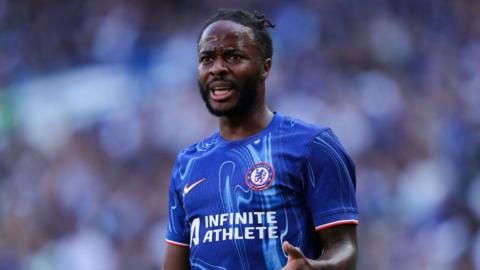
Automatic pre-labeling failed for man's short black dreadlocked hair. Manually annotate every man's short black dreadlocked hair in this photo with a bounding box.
[198,9,275,59]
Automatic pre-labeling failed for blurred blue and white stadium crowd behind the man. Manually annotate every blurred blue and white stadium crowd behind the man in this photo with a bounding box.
[0,0,480,270]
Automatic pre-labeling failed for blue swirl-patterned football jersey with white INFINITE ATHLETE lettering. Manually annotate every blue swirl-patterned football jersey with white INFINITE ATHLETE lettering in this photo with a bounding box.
[166,113,358,270]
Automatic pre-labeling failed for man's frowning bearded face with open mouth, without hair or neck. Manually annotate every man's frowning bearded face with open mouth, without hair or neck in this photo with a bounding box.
[198,20,263,116]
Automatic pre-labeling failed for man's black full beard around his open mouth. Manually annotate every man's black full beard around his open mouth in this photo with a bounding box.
[198,75,261,117]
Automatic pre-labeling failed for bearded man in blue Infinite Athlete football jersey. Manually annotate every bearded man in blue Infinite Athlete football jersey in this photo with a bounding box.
[164,10,358,270]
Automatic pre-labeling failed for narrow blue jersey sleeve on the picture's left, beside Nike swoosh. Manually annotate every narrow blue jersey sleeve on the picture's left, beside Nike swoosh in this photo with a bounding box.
[165,157,190,247]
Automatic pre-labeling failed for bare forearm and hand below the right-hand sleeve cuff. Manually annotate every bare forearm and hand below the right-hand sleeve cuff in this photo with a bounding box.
[283,224,357,270]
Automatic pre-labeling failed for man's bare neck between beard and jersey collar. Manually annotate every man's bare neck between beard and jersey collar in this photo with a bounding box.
[219,104,273,140]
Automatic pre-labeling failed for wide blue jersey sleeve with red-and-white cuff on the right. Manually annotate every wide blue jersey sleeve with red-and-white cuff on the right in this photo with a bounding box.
[304,129,358,231]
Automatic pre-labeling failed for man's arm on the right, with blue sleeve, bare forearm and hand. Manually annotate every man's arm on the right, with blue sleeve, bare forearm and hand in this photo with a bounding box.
[283,130,358,270]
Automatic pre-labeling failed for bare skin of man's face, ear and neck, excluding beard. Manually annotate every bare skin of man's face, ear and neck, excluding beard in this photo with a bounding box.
[198,21,273,140]
